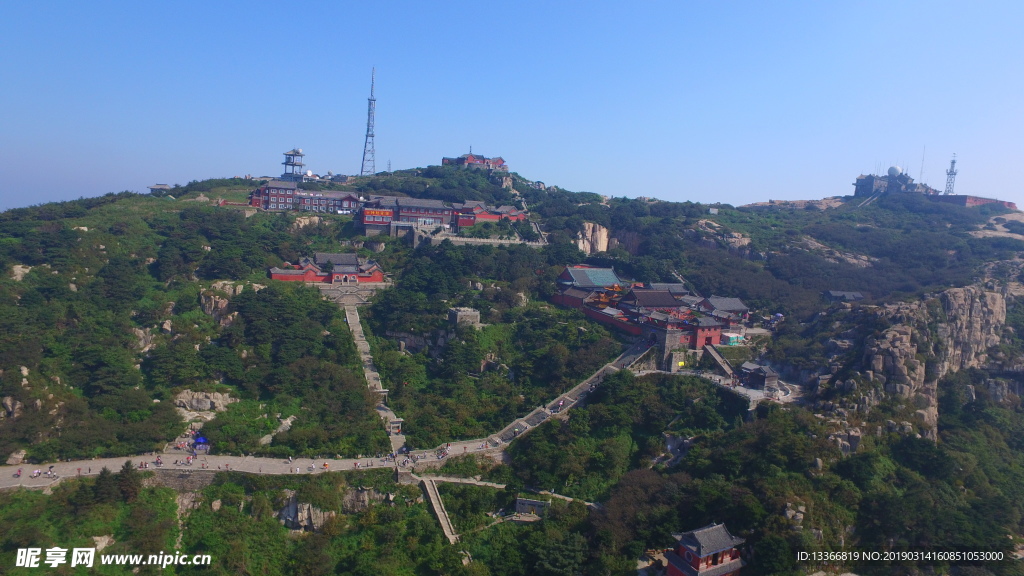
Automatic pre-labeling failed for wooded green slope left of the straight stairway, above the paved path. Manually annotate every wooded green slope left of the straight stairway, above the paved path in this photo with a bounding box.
[0,194,386,459]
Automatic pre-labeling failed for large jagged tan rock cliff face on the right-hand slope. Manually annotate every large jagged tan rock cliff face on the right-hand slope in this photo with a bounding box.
[862,286,1007,439]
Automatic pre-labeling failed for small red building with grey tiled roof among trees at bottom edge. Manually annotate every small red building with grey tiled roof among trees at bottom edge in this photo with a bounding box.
[665,524,745,576]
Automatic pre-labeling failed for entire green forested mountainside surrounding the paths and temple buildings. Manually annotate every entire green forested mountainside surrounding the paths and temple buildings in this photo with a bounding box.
[6,176,1024,575]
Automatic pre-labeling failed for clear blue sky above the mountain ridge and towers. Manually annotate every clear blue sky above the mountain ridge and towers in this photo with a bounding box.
[0,1,1024,208]
